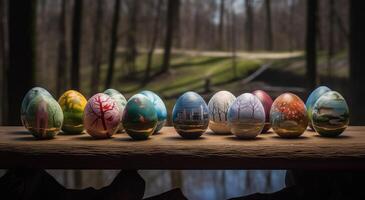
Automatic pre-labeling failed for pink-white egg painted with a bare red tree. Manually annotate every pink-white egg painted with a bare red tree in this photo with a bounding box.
[83,93,121,138]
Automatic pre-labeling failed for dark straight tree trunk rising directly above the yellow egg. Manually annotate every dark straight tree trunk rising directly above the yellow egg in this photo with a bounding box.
[71,0,83,90]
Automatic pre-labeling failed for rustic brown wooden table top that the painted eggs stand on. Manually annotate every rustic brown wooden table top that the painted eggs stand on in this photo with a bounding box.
[0,126,365,169]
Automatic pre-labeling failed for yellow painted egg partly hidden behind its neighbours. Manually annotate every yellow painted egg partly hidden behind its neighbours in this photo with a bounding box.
[58,90,87,134]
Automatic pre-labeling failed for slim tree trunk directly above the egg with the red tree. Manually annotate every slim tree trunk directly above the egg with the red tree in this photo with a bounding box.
[90,0,104,94]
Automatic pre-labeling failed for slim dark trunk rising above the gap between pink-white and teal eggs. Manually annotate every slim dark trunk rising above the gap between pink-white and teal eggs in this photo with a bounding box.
[105,0,120,89]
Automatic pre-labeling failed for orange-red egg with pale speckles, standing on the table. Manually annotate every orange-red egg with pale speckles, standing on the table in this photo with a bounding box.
[270,93,308,138]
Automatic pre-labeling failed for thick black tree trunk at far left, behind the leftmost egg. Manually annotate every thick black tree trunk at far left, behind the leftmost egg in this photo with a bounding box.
[7,0,36,125]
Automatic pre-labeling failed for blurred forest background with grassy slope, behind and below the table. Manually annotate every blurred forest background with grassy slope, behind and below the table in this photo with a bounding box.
[0,0,365,199]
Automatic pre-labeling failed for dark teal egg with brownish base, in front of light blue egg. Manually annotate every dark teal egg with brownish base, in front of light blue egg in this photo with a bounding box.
[123,94,158,140]
